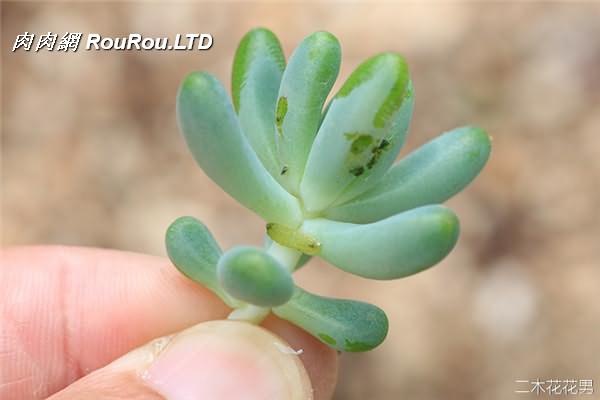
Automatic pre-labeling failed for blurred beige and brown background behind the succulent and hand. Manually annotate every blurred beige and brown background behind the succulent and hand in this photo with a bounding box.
[1,2,600,400]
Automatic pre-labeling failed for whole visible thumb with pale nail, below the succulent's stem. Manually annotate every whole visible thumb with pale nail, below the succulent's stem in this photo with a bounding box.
[50,321,313,400]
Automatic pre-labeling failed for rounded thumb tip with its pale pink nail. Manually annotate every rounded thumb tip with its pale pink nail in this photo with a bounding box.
[142,321,313,400]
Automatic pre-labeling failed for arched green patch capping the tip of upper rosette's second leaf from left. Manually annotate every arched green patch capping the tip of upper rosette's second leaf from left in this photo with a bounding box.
[231,28,285,112]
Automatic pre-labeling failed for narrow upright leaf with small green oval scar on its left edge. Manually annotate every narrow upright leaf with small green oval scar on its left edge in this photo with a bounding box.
[275,32,341,194]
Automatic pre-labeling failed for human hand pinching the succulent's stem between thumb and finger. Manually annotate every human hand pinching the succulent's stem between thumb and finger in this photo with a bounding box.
[0,246,337,400]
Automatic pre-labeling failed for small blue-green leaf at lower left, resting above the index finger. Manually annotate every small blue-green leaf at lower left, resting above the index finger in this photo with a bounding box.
[165,217,236,307]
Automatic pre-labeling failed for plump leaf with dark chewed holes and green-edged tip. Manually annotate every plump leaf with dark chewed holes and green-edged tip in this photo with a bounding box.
[300,53,413,212]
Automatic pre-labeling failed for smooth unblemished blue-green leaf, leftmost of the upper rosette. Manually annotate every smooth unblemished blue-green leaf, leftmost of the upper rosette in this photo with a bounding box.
[177,72,301,226]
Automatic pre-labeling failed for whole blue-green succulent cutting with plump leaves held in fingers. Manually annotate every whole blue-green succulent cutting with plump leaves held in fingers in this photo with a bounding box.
[166,28,490,352]
